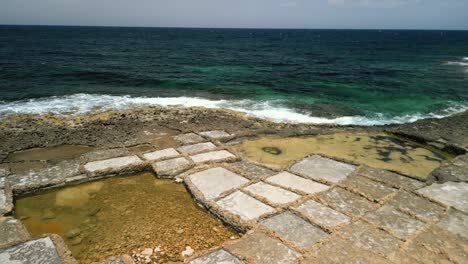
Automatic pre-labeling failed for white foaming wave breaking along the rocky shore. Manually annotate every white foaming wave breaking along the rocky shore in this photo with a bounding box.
[0,94,468,125]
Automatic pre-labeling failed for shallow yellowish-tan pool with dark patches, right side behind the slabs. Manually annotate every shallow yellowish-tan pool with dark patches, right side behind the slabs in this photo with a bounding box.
[235,133,453,179]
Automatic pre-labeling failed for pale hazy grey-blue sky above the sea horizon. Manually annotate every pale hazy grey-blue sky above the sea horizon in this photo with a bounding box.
[0,0,468,30]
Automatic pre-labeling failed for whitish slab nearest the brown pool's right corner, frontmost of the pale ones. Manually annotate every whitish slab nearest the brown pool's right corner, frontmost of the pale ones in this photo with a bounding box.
[216,191,274,221]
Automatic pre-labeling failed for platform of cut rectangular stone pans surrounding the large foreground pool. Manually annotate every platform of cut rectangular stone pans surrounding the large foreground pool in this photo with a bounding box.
[0,130,468,264]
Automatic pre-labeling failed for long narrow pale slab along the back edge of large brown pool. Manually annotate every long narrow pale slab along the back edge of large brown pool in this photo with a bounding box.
[84,155,143,176]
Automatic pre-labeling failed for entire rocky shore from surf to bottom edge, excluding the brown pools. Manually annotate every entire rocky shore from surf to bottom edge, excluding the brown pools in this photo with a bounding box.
[0,107,468,264]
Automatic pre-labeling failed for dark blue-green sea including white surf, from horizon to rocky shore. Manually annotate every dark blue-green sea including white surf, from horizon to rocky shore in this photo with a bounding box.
[0,26,468,124]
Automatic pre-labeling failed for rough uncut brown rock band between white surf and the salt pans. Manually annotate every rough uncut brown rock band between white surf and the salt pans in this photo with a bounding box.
[0,107,468,160]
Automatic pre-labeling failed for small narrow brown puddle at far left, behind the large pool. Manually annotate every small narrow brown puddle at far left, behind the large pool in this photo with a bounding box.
[6,145,94,162]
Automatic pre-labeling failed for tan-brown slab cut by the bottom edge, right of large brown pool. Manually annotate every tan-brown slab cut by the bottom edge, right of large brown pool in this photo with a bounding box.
[226,232,301,264]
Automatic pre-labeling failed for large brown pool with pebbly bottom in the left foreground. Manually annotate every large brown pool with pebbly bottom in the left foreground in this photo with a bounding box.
[15,172,237,263]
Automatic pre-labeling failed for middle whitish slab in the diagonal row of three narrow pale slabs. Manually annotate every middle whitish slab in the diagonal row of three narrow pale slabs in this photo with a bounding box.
[245,182,301,204]
